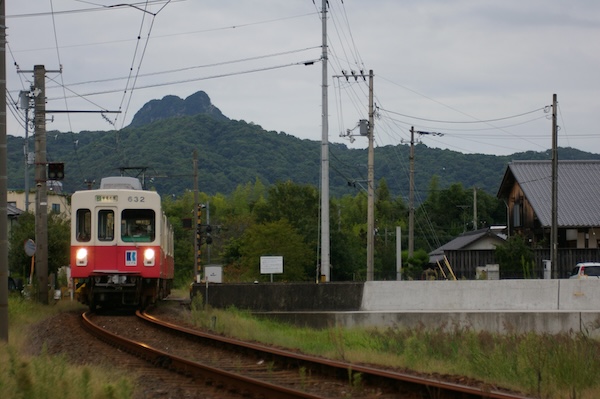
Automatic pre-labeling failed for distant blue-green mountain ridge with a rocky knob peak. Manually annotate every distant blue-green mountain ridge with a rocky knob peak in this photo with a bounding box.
[7,92,600,202]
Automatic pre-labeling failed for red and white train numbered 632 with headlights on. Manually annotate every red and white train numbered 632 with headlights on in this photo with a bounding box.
[71,176,174,310]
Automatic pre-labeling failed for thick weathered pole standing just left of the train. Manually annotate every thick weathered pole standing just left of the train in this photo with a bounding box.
[33,65,48,305]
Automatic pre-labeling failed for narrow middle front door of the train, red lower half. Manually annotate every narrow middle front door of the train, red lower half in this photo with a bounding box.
[95,207,119,271]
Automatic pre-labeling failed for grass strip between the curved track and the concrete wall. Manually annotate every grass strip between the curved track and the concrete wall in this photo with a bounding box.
[191,299,600,399]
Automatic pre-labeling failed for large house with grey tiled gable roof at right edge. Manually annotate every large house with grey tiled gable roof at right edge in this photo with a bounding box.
[497,160,600,249]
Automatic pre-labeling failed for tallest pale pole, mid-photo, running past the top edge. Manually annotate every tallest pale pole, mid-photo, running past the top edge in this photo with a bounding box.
[319,0,331,282]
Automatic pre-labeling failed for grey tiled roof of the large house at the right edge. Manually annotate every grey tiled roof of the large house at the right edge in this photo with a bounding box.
[498,160,600,227]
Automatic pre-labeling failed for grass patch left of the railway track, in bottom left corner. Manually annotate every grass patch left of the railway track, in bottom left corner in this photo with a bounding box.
[0,296,134,399]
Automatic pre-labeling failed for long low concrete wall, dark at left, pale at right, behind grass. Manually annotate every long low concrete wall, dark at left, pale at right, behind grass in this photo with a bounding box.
[193,280,600,338]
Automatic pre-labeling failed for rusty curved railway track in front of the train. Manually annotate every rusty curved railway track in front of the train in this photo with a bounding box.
[82,312,526,399]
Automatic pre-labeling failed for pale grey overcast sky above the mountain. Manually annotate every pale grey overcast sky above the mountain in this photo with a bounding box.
[6,0,600,155]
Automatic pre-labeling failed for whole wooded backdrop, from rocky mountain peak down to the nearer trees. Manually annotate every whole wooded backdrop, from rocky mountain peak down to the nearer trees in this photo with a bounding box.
[8,94,600,284]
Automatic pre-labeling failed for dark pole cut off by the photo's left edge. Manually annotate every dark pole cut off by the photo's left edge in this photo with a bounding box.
[0,1,8,342]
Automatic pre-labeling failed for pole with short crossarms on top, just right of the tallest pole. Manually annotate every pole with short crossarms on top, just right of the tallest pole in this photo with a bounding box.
[367,69,375,281]
